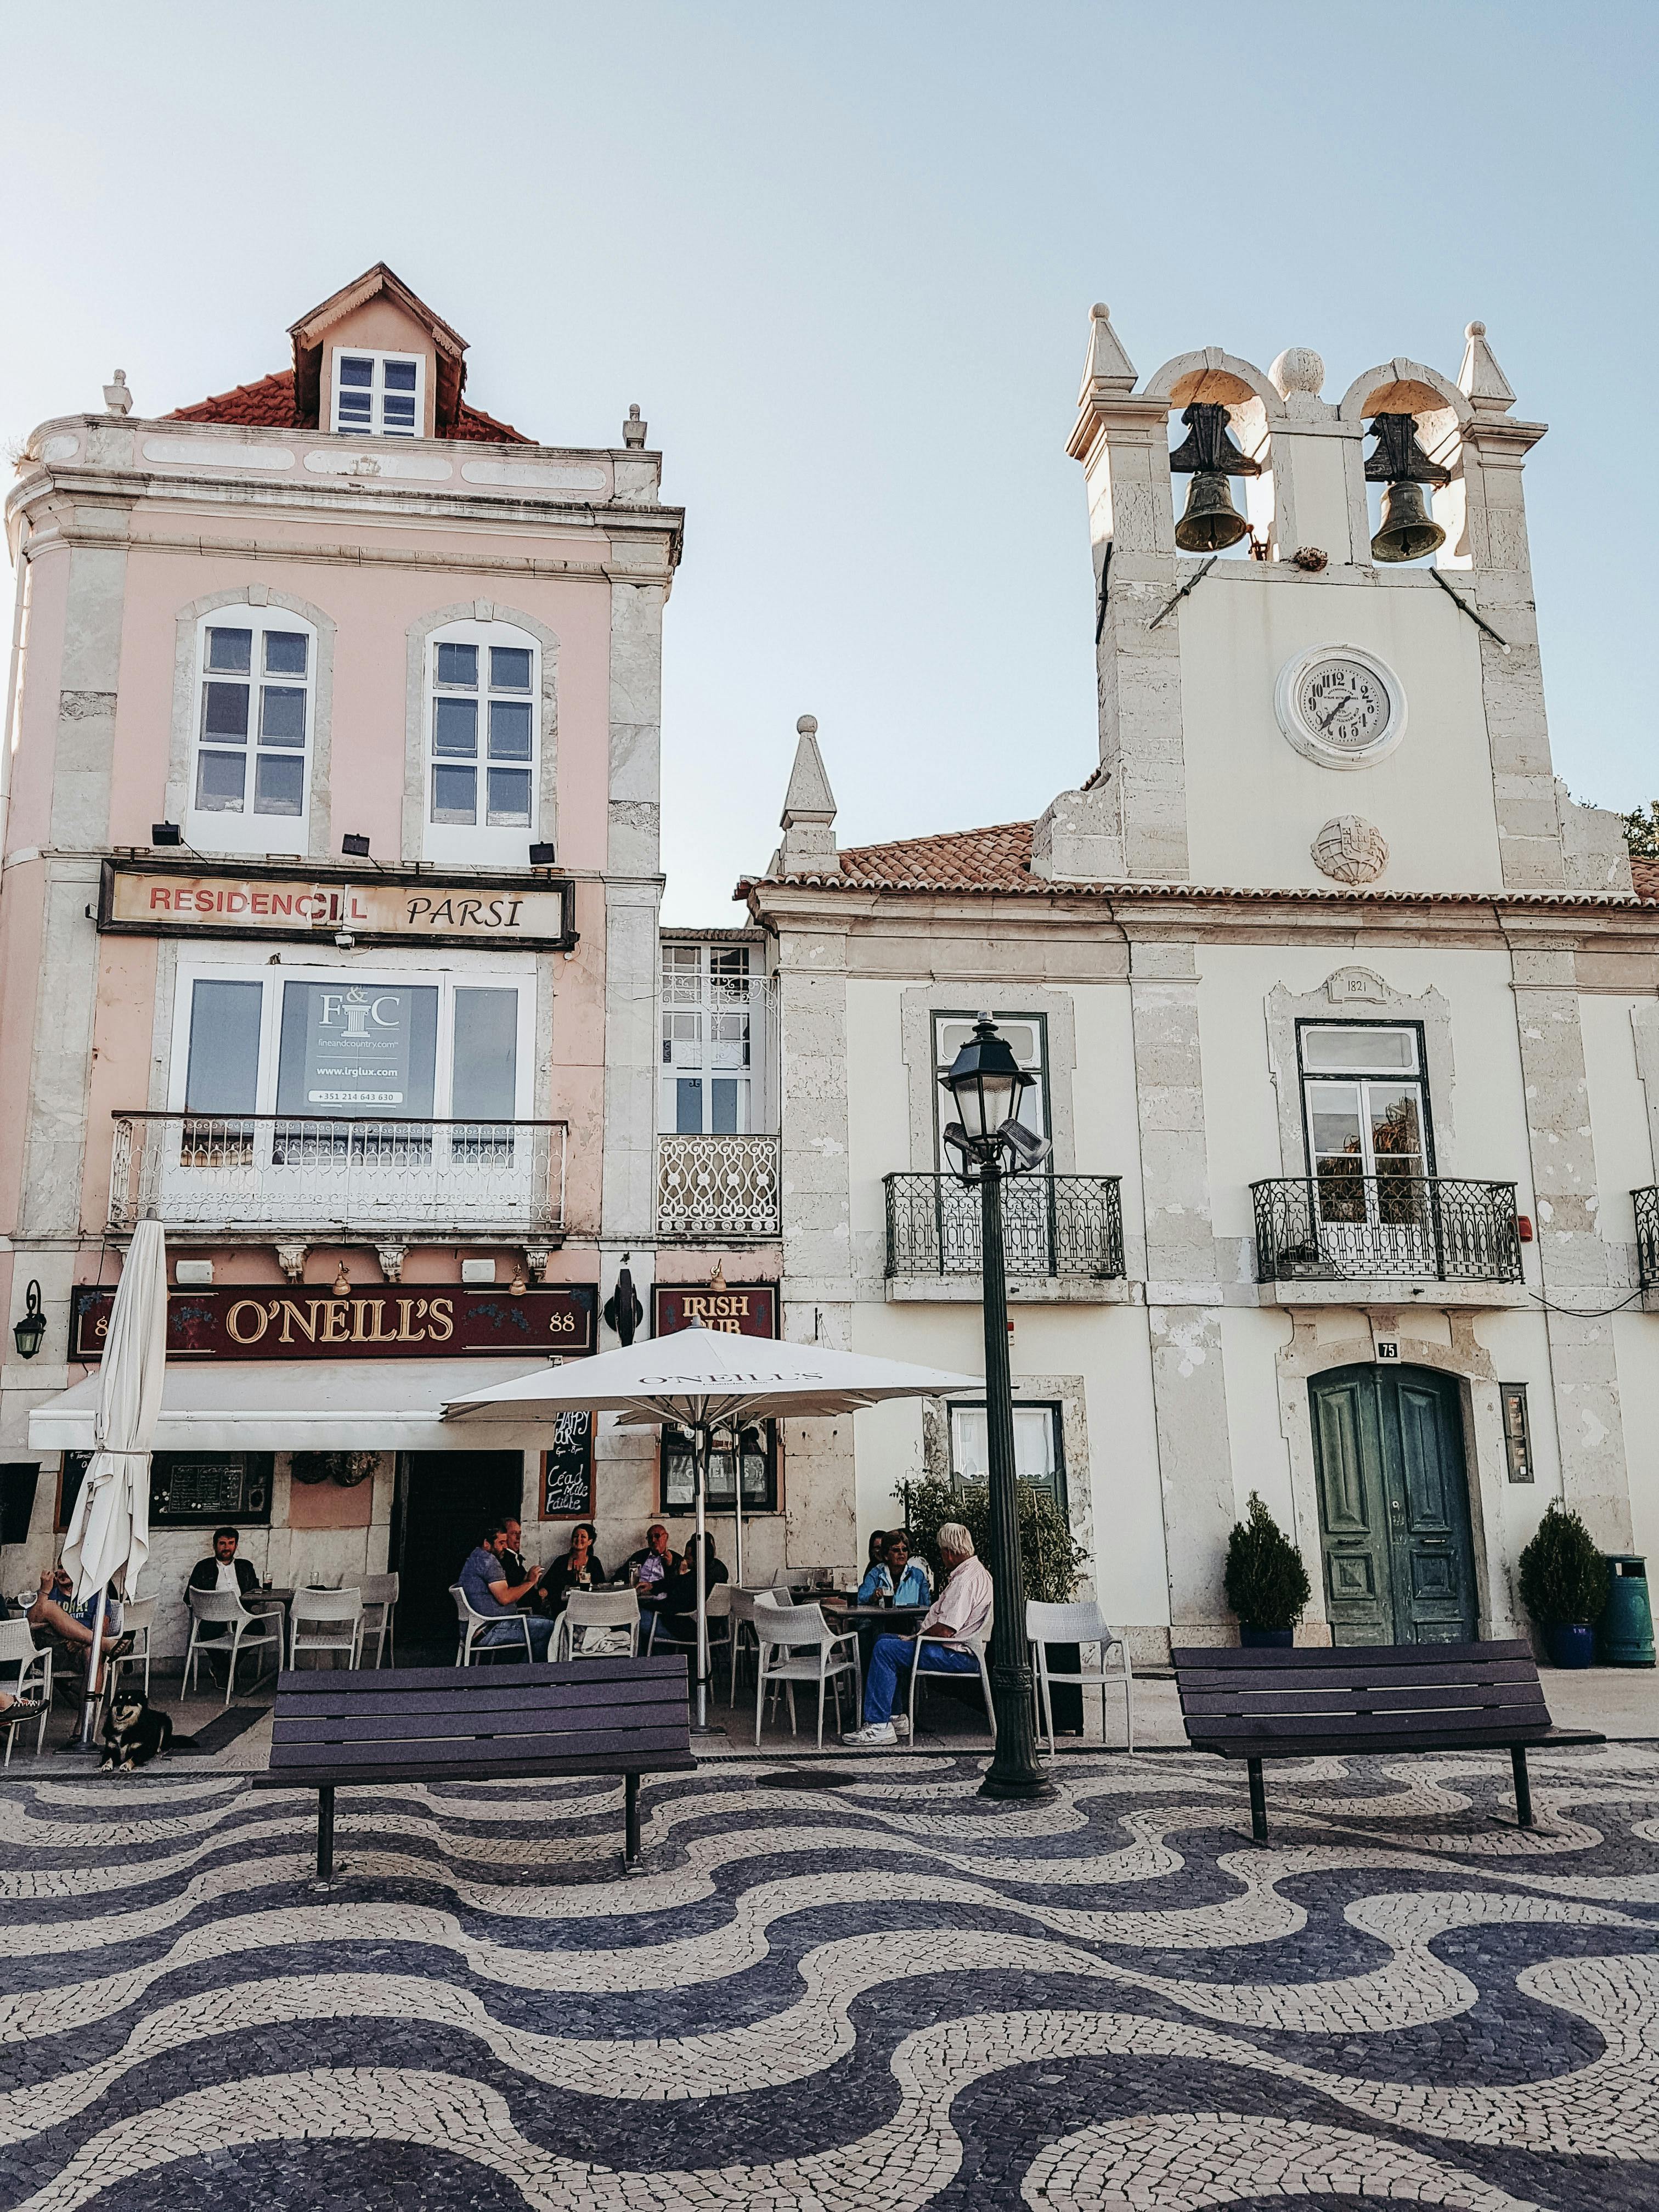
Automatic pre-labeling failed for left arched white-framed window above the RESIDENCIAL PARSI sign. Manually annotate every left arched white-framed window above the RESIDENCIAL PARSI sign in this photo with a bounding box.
[186,606,317,854]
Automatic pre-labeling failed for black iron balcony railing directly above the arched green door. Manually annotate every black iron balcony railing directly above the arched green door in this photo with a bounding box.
[1250,1161,1522,1283]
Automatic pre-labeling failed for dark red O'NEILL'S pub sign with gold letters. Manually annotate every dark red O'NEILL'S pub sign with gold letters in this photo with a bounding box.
[69,1283,597,1363]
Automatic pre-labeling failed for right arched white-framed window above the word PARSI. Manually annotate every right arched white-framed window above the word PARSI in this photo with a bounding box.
[425,622,542,867]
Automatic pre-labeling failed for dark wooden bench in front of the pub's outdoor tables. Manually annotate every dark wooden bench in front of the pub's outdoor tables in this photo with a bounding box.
[255,1655,697,1882]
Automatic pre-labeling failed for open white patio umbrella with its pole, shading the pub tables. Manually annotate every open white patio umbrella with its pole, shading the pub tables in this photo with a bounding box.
[444,1323,984,1730]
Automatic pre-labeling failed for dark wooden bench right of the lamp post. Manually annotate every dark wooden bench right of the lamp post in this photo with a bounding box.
[1170,1641,1606,1843]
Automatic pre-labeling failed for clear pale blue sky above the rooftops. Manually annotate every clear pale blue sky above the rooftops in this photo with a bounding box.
[0,0,1659,922]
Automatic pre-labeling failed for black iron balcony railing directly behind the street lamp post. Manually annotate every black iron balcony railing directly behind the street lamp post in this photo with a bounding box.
[885,1175,1124,1281]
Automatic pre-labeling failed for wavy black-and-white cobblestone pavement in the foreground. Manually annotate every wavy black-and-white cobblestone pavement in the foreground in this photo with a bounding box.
[0,1745,1659,2212]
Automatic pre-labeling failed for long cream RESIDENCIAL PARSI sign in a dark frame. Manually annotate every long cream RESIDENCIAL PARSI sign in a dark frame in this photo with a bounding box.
[97,860,575,949]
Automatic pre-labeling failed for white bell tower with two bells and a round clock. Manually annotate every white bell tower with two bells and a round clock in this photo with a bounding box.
[1033,307,1630,891]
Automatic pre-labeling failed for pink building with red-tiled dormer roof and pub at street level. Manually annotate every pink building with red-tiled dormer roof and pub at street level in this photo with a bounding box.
[0,266,796,1648]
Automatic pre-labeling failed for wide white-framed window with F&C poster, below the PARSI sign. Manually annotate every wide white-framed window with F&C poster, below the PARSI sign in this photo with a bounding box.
[170,962,535,1126]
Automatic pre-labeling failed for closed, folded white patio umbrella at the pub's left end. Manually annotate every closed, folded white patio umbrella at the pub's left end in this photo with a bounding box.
[64,1221,168,1745]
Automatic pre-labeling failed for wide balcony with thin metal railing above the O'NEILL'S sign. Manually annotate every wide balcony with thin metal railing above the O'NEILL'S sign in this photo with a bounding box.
[109,1113,566,1237]
